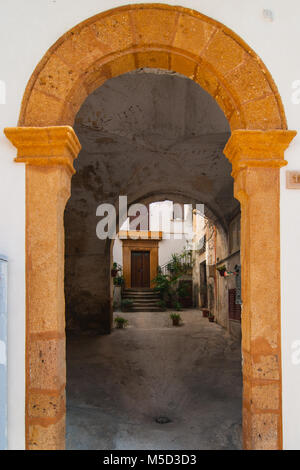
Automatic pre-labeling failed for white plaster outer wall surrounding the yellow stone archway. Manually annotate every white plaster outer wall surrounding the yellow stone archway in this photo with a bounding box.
[0,0,300,449]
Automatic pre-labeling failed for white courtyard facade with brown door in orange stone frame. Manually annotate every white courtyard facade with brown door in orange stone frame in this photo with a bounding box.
[113,201,193,288]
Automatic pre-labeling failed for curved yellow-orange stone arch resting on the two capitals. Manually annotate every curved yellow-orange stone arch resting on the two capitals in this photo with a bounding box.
[19,4,287,130]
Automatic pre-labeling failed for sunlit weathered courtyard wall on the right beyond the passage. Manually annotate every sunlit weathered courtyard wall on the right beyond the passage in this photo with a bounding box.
[193,209,242,341]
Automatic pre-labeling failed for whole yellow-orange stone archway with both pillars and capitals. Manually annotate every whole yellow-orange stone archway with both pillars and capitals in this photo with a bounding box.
[5,4,295,449]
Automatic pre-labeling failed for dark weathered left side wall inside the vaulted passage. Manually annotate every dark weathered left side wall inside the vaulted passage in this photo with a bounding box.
[65,160,111,333]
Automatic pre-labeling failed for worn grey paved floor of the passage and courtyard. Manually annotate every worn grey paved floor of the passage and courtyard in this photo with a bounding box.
[67,310,242,450]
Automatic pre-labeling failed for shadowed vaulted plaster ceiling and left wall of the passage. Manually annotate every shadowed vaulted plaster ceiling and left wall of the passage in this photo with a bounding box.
[65,69,239,333]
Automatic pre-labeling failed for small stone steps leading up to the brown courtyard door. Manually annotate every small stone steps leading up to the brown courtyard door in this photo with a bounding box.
[122,288,162,312]
